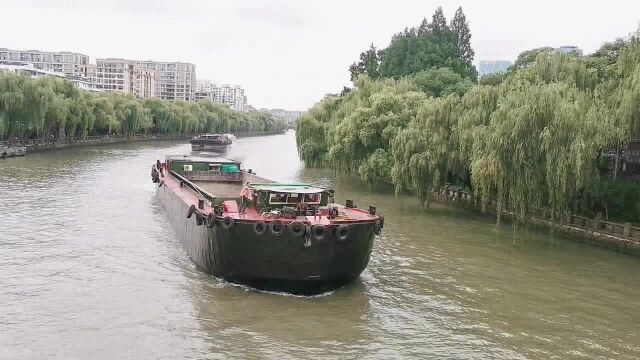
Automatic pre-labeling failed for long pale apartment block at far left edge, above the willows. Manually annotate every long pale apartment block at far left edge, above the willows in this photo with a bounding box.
[0,48,89,77]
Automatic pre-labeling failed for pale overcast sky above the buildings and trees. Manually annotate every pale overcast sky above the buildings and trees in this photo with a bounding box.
[0,0,640,110]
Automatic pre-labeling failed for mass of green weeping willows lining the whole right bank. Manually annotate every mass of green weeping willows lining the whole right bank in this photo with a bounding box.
[298,37,640,221]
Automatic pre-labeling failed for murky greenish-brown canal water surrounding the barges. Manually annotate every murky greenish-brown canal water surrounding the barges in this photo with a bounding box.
[0,132,640,359]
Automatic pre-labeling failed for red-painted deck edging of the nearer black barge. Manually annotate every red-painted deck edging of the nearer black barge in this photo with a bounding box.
[160,172,380,225]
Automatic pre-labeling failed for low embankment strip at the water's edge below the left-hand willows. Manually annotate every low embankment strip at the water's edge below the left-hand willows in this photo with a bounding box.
[0,130,284,158]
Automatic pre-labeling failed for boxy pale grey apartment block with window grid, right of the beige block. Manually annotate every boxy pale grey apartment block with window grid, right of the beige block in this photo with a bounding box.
[137,60,196,101]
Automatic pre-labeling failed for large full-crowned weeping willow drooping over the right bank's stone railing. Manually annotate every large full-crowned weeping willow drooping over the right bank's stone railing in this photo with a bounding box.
[471,83,606,221]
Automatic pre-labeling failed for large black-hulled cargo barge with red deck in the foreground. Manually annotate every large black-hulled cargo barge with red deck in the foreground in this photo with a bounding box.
[153,155,384,295]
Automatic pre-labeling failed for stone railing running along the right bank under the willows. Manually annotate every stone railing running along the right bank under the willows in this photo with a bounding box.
[435,188,640,243]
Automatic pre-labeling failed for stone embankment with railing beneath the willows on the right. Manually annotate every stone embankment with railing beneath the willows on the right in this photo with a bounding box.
[433,189,640,257]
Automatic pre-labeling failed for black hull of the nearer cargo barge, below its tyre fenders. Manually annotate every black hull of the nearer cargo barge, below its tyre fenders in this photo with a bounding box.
[158,181,374,295]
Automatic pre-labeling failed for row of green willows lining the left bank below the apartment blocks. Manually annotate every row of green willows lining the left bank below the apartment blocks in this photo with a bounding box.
[0,73,286,139]
